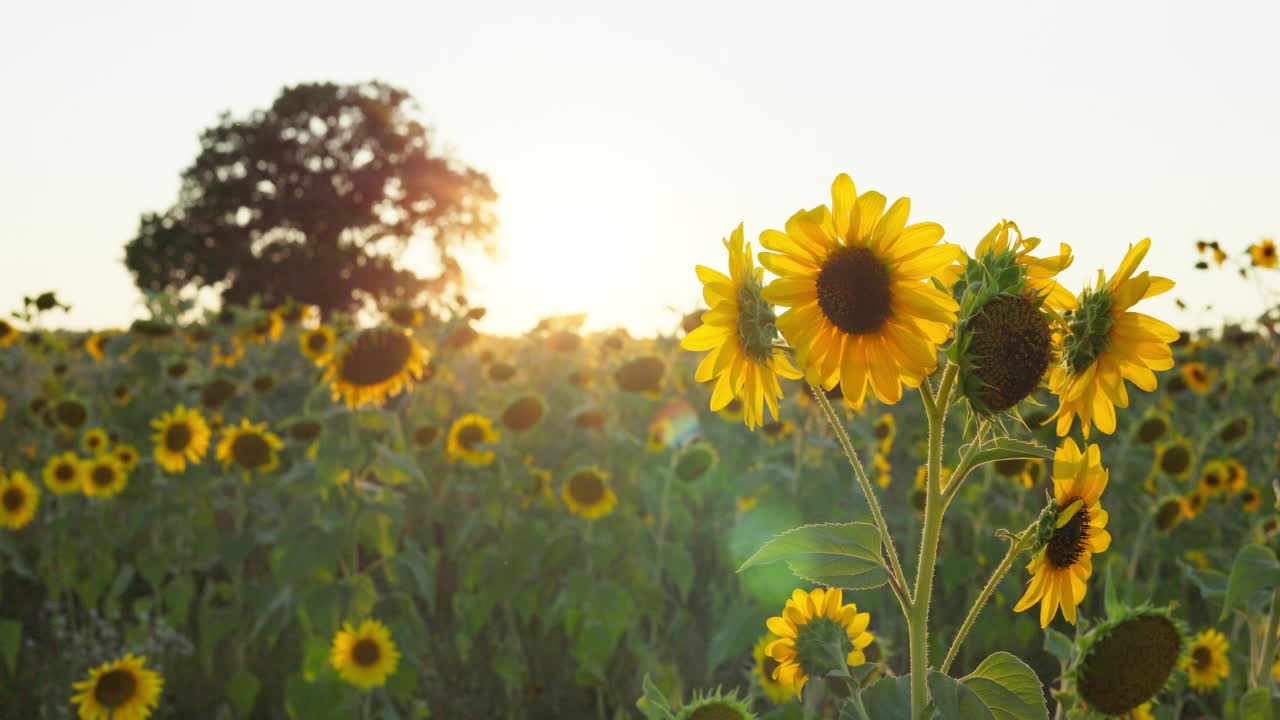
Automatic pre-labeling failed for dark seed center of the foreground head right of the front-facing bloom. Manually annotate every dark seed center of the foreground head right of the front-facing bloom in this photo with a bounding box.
[969,296,1052,413]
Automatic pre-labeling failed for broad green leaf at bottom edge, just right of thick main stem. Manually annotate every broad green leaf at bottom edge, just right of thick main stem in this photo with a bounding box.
[929,652,1048,720]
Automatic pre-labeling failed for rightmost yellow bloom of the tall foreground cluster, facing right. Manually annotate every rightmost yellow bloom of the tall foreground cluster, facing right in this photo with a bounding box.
[1050,238,1178,438]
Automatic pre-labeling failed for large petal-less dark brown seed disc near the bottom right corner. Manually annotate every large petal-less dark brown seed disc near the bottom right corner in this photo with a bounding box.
[1069,606,1187,716]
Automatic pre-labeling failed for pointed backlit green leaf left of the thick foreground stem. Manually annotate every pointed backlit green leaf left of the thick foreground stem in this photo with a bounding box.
[739,523,888,589]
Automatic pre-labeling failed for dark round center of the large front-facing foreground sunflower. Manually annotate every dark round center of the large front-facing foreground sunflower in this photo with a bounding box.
[818,247,891,334]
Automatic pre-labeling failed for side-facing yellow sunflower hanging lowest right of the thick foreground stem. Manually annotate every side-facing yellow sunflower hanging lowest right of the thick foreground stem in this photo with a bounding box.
[1014,438,1111,628]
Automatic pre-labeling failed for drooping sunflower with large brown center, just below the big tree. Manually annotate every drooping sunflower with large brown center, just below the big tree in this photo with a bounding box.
[324,327,430,409]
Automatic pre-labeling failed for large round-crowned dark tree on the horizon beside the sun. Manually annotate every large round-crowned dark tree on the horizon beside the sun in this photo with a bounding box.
[124,82,497,314]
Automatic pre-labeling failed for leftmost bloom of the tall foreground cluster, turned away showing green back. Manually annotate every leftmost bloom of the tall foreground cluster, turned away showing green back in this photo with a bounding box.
[680,224,800,429]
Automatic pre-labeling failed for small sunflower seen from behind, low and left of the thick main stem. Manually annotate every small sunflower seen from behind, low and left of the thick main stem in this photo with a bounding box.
[764,588,874,697]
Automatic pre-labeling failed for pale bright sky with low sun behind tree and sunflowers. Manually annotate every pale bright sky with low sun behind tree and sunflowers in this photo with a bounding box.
[0,0,1280,334]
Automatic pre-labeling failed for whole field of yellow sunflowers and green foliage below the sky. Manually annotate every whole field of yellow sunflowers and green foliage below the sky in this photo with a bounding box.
[0,176,1280,720]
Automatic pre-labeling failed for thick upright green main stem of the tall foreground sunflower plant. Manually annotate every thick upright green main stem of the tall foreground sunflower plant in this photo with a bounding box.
[906,363,960,719]
